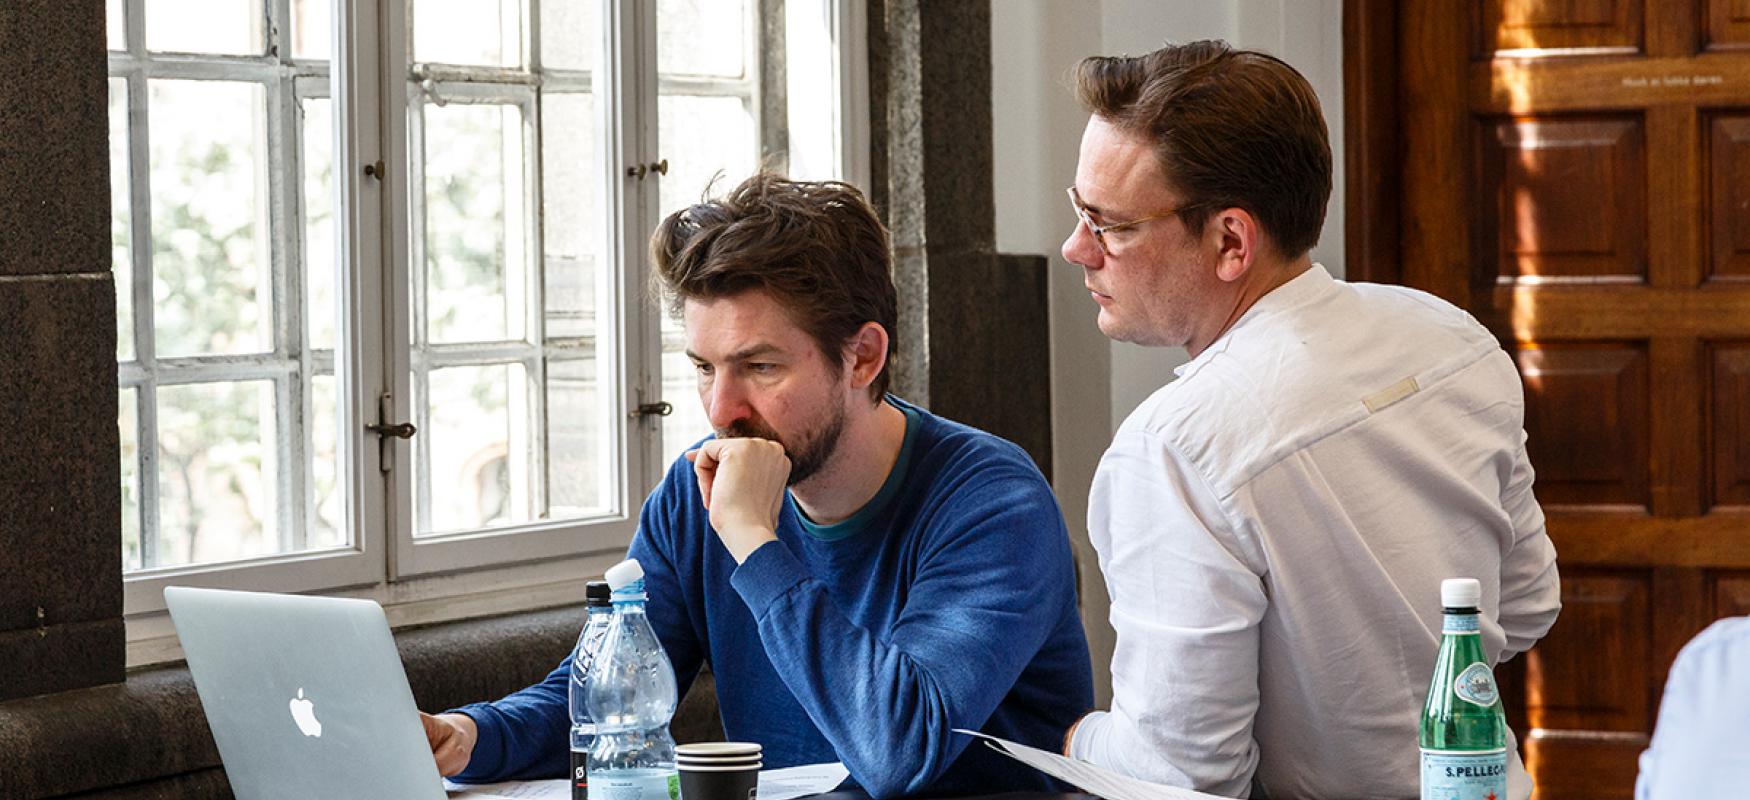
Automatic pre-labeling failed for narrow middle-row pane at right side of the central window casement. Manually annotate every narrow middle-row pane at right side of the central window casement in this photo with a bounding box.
[541,93,606,338]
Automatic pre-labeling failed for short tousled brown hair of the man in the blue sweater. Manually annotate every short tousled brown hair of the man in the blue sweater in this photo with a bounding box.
[651,172,900,399]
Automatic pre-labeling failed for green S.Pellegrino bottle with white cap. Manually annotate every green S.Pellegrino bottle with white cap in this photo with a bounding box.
[1421,578,1507,800]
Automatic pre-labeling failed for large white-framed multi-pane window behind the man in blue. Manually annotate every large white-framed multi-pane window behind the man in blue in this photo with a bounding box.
[109,0,866,663]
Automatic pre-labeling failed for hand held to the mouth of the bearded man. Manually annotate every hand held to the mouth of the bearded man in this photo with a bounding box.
[686,439,789,564]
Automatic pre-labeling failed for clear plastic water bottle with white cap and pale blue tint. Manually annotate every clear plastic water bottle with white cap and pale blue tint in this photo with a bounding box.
[588,558,681,800]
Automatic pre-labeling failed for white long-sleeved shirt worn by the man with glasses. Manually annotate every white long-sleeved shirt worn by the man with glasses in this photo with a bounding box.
[1069,264,1561,798]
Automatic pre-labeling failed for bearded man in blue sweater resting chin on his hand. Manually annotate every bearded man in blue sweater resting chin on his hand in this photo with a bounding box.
[416,175,1092,796]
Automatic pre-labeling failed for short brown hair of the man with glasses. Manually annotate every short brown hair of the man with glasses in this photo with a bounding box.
[1076,40,1332,257]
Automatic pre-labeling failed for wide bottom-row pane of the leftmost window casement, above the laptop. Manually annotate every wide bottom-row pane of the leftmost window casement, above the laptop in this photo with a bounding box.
[147,380,287,567]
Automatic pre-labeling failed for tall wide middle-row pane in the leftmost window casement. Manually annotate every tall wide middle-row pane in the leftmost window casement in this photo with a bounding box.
[149,81,273,357]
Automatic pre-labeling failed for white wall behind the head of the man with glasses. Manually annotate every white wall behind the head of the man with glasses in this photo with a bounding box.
[991,0,1344,705]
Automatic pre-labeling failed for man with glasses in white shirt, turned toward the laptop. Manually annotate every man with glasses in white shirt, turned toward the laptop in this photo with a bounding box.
[1062,42,1561,798]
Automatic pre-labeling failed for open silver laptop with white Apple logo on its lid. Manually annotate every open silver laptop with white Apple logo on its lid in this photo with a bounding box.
[165,586,446,800]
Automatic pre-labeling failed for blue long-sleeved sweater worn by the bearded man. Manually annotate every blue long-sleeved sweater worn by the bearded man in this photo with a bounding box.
[459,397,1094,798]
